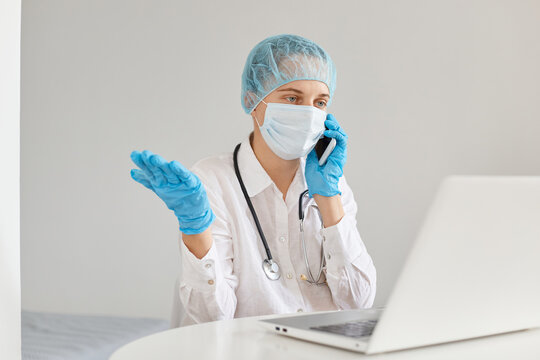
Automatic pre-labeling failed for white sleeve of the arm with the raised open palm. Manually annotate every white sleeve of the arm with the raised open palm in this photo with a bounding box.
[179,170,238,323]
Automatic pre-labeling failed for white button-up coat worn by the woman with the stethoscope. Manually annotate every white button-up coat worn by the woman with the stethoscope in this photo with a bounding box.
[171,137,376,327]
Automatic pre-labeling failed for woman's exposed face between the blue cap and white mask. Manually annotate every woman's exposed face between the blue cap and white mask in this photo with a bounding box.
[252,80,330,126]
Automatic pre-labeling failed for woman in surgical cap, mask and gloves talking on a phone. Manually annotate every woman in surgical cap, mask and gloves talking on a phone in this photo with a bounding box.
[131,34,376,325]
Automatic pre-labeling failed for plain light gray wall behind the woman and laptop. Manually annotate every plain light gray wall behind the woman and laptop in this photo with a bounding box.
[21,0,540,318]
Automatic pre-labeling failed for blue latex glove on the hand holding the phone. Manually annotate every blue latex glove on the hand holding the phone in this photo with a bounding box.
[305,114,347,197]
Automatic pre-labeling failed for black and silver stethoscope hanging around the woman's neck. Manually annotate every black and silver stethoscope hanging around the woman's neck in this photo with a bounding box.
[233,144,326,285]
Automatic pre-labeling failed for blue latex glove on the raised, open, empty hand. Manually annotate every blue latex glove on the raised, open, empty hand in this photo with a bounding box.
[131,150,215,234]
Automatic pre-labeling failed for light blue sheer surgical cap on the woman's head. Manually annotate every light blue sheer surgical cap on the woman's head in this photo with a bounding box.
[241,34,336,114]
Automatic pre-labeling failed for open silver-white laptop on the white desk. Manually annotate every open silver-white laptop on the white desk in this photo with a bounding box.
[260,176,540,354]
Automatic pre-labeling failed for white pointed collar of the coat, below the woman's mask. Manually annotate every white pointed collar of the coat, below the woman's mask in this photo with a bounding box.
[238,134,307,197]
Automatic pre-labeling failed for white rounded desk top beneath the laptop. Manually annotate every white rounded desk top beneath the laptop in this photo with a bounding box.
[110,315,540,360]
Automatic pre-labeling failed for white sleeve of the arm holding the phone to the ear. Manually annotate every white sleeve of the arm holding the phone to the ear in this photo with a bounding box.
[321,176,376,309]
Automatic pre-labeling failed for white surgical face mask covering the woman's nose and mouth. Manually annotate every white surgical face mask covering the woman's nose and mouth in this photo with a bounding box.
[255,100,326,160]
